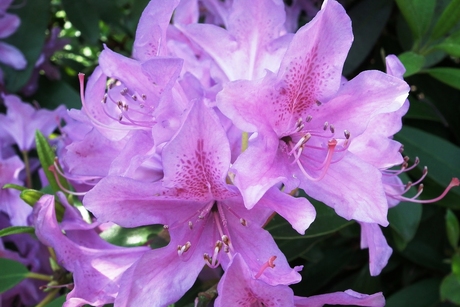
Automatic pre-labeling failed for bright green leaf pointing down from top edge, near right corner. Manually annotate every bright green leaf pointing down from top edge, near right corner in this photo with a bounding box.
[396,0,436,39]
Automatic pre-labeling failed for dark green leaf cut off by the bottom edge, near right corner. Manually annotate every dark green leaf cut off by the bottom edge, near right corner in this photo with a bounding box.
[385,279,440,307]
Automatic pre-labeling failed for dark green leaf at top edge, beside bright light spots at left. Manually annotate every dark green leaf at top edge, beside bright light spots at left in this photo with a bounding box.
[62,0,99,45]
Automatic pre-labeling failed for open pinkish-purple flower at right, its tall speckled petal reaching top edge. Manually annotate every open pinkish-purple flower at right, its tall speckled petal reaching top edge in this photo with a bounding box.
[217,1,409,226]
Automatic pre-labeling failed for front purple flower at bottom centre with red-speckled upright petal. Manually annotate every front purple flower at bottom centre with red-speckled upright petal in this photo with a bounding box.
[83,101,315,306]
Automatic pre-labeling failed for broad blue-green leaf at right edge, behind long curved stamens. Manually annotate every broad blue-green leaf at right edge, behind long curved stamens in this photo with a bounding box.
[395,127,460,196]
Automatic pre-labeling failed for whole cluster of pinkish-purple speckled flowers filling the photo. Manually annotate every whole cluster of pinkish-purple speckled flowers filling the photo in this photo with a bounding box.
[0,0,459,307]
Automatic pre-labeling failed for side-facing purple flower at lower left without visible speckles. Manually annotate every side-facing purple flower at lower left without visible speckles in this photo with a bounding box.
[34,195,149,306]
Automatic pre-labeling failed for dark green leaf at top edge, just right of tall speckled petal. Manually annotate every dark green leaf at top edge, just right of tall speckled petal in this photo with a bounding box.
[343,0,393,75]
